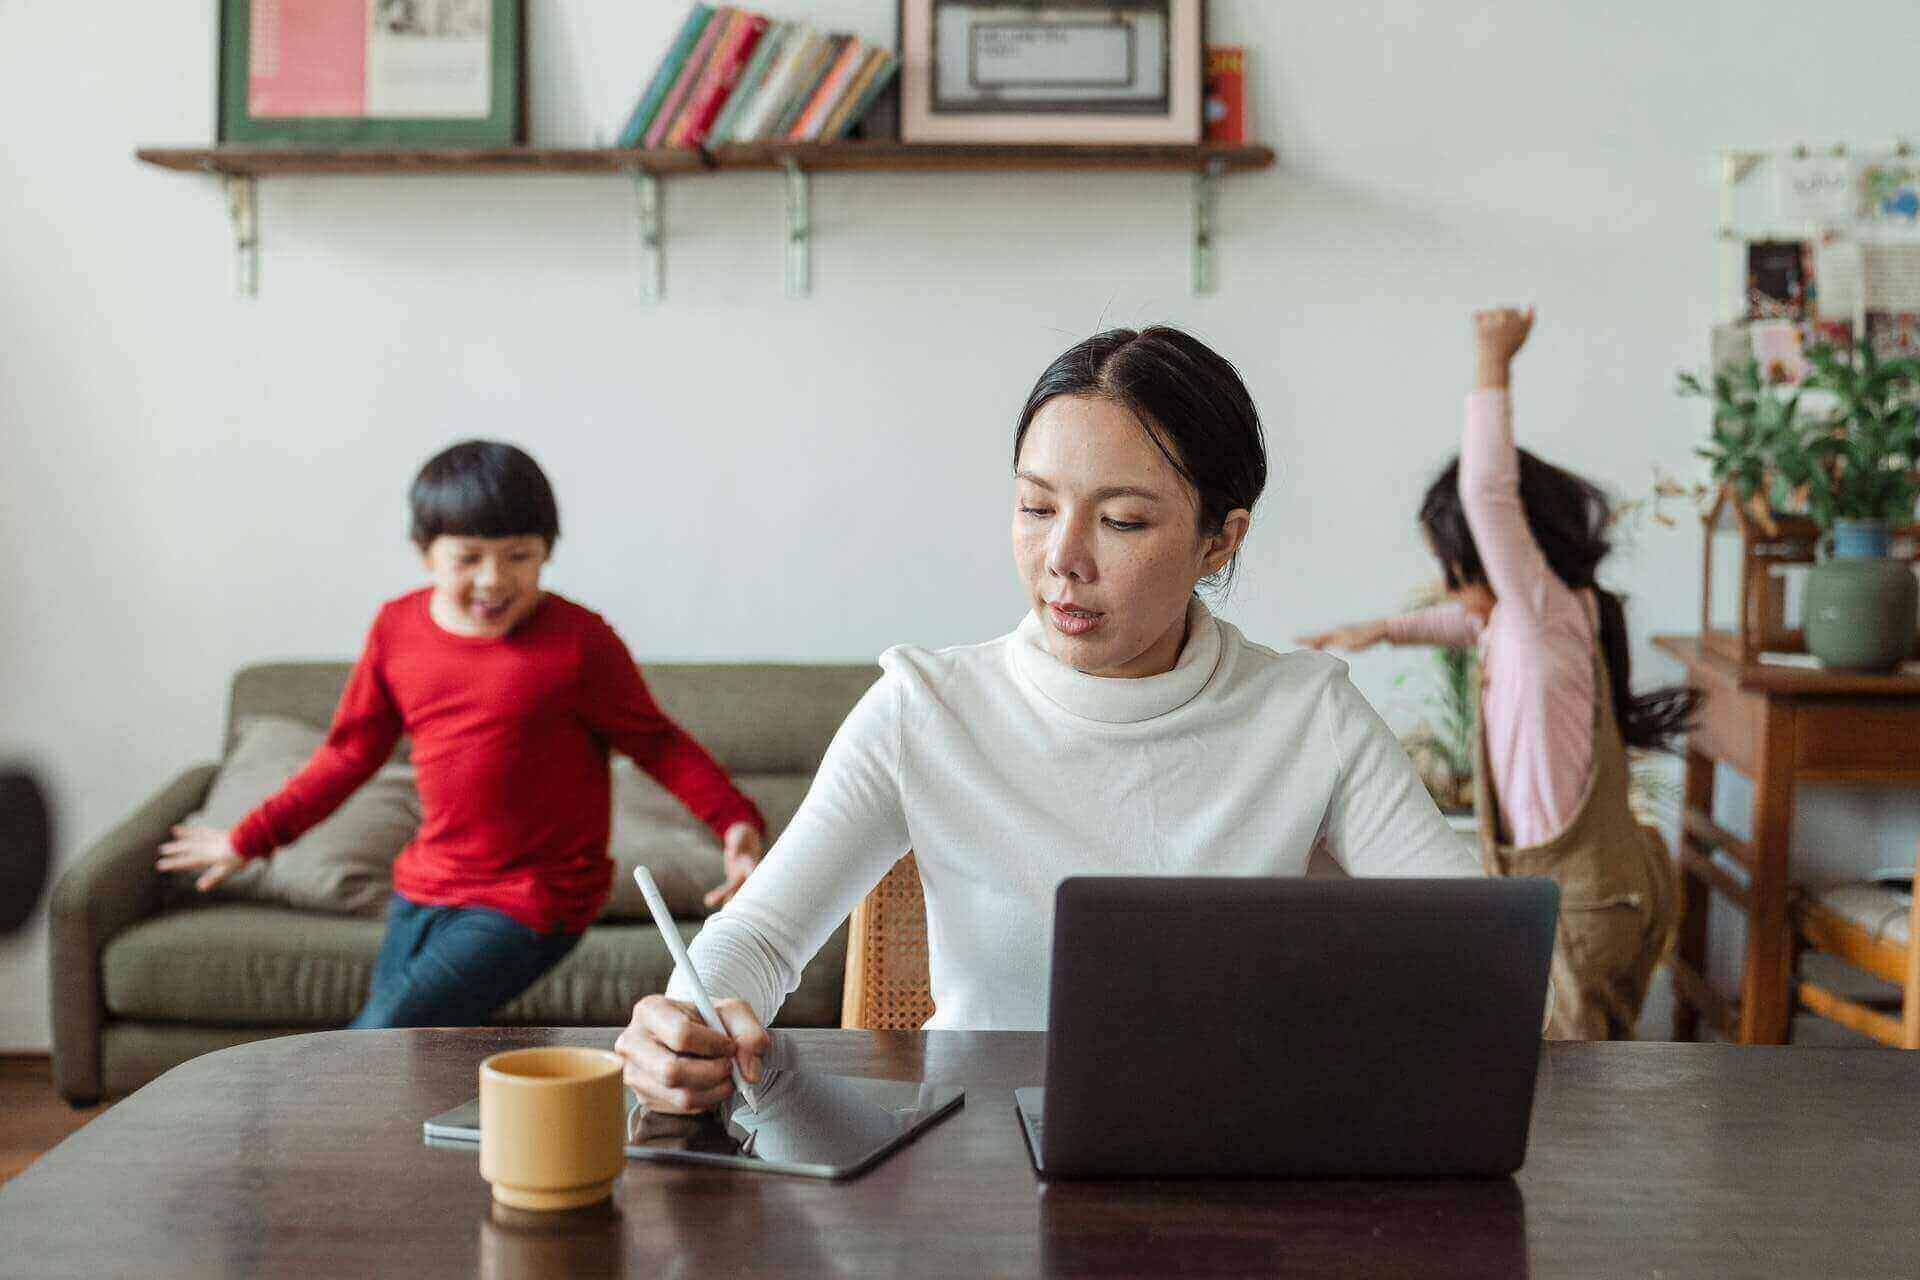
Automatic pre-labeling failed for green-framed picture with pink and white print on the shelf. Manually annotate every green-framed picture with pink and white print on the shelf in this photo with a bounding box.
[219,0,526,148]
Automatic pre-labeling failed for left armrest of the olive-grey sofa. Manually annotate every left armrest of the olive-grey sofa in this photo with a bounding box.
[48,764,219,1105]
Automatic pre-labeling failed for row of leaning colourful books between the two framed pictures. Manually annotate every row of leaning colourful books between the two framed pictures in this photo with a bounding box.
[616,4,900,148]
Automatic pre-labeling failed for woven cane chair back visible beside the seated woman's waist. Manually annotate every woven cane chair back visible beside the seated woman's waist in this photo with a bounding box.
[841,854,933,1031]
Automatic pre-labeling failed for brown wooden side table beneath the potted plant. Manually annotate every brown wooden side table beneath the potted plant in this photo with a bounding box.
[1653,635,1920,1044]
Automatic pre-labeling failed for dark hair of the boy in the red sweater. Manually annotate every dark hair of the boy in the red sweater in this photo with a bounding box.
[409,439,561,551]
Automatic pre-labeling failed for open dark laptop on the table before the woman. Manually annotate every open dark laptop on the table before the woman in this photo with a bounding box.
[1014,877,1559,1178]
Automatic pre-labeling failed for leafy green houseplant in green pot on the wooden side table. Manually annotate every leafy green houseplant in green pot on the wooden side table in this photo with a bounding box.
[1680,345,1920,670]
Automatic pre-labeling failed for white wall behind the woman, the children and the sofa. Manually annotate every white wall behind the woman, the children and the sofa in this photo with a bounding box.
[0,0,1920,1048]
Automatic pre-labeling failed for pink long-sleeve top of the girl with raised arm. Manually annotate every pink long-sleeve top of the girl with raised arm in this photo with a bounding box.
[1386,390,1596,848]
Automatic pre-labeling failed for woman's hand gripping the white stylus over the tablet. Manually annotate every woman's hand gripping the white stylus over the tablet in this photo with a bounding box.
[612,996,774,1115]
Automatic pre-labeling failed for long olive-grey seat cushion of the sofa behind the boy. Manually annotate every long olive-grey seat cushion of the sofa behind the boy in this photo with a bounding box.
[102,902,847,1027]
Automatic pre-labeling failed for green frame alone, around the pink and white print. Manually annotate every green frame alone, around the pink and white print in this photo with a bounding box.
[215,0,526,150]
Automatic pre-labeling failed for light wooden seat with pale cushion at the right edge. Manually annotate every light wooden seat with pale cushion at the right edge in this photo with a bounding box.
[1793,844,1920,1050]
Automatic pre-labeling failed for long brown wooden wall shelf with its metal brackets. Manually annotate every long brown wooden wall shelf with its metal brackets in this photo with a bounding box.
[134,142,1273,301]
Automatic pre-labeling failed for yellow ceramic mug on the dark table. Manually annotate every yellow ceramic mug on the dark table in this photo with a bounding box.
[480,1048,626,1209]
